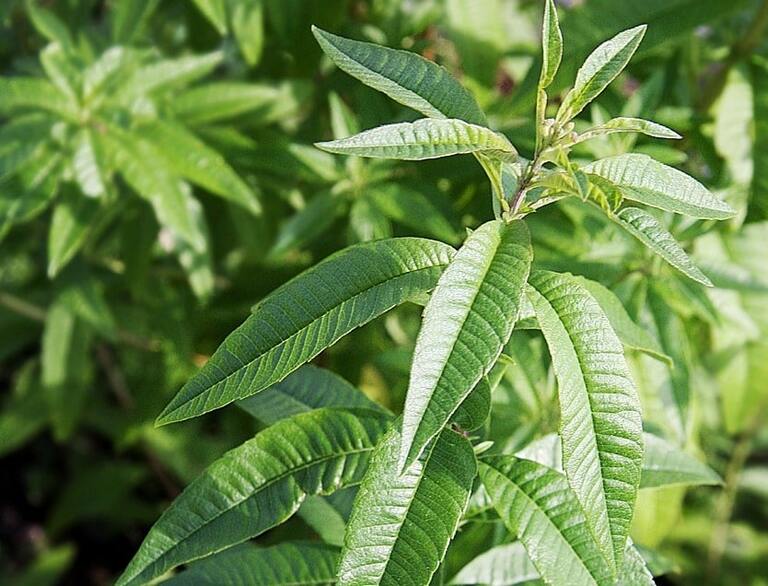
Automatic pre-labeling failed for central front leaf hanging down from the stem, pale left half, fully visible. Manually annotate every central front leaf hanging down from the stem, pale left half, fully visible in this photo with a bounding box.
[400,220,533,469]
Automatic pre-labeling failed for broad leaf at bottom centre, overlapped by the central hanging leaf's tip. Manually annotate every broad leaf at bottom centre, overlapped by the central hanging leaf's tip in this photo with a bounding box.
[338,428,477,586]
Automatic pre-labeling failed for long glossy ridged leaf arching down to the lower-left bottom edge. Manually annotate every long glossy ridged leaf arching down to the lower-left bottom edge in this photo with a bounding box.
[117,409,387,586]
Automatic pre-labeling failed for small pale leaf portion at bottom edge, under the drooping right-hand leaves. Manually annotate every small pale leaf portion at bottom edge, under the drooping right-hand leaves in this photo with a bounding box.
[449,541,539,586]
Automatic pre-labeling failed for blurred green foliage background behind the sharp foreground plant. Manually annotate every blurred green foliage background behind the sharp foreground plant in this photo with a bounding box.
[0,0,768,586]
